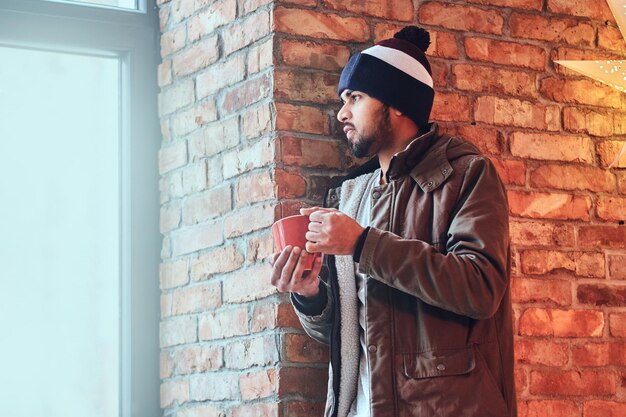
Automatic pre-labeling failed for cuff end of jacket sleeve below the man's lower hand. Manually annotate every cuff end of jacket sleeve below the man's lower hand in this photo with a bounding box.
[291,279,334,345]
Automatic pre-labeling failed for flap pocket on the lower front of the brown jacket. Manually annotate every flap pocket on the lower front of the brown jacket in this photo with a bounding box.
[396,346,509,417]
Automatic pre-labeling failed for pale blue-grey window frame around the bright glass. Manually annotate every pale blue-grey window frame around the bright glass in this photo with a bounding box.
[0,0,161,417]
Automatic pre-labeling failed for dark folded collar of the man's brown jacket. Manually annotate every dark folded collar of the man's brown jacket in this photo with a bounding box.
[387,123,452,192]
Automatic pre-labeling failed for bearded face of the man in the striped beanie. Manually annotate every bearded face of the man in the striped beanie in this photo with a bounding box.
[337,90,391,158]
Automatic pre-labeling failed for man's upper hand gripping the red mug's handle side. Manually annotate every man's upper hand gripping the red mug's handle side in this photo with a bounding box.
[300,207,365,255]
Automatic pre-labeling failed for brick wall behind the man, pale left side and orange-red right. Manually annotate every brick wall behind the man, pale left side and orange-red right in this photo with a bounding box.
[158,0,626,417]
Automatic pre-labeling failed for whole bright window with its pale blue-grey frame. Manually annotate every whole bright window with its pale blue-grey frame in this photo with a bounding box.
[0,0,161,417]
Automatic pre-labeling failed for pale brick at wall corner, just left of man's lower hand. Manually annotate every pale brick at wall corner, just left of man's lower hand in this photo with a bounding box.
[223,263,276,304]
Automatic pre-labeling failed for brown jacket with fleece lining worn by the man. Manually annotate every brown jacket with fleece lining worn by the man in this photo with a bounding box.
[292,124,517,417]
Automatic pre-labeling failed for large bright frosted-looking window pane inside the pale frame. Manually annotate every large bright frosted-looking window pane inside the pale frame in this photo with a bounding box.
[0,47,121,417]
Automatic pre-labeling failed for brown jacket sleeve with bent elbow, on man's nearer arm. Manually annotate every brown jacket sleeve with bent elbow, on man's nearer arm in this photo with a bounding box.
[359,157,509,319]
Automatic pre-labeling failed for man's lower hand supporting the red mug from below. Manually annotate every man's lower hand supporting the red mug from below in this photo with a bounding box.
[270,246,322,297]
